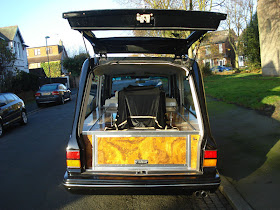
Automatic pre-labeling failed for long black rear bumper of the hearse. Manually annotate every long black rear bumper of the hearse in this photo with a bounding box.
[63,172,221,191]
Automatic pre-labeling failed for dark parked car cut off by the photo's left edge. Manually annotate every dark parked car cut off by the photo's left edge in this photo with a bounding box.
[0,93,27,137]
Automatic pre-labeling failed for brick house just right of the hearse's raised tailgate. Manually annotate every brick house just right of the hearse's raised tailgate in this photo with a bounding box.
[198,30,235,68]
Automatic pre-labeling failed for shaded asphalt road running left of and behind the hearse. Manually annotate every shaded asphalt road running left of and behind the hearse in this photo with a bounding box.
[0,96,232,209]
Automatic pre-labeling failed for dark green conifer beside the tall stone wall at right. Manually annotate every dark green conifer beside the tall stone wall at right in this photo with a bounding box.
[242,13,261,66]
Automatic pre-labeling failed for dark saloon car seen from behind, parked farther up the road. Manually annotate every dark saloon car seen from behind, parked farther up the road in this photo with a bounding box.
[35,83,71,107]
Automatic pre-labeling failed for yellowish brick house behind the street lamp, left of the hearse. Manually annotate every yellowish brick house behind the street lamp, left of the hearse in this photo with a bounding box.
[27,40,68,77]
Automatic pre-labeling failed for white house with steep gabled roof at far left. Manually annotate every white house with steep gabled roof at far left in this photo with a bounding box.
[0,26,29,73]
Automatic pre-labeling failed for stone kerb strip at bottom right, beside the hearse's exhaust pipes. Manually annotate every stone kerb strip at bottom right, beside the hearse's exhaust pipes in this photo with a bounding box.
[219,175,253,210]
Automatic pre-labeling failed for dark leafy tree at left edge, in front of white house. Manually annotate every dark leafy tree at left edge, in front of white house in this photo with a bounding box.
[0,39,16,75]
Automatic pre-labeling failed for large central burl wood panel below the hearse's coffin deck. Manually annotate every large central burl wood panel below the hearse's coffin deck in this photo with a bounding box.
[98,137,186,164]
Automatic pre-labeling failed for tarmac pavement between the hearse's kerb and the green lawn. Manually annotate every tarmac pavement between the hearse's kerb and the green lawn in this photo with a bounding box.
[207,98,280,209]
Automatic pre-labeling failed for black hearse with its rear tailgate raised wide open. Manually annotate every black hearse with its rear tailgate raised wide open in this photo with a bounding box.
[63,9,226,195]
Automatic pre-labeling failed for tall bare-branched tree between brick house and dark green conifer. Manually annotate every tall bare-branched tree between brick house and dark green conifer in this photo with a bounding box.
[225,0,254,68]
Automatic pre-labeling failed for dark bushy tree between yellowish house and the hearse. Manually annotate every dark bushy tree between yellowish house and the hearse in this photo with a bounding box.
[63,53,88,76]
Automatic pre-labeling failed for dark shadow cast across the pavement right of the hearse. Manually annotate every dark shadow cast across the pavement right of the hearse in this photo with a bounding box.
[207,98,280,181]
